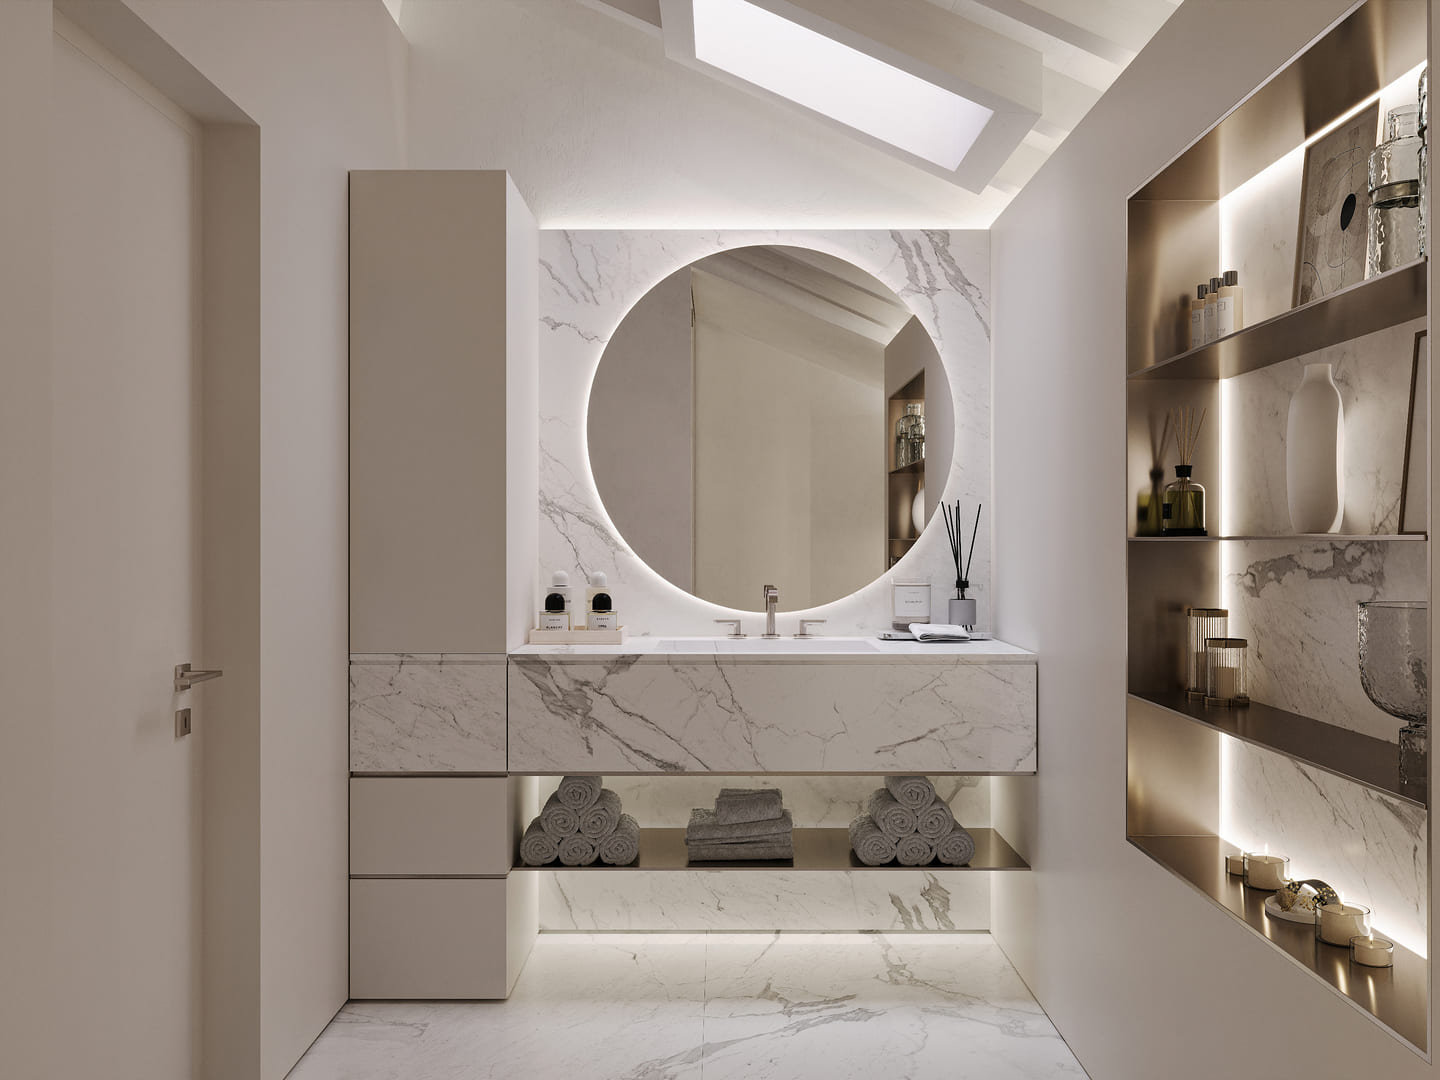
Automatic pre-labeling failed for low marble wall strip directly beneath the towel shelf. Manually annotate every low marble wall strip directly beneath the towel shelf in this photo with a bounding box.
[539,867,991,932]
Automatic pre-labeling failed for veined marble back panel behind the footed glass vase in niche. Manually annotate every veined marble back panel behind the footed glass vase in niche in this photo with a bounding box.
[1221,540,1428,742]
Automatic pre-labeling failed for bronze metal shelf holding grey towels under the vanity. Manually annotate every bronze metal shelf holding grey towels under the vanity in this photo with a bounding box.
[516,828,1030,873]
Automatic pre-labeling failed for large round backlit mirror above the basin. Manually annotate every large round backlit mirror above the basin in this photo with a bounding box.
[588,246,953,611]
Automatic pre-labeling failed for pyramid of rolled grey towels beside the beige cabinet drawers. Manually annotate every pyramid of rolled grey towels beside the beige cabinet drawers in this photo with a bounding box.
[520,776,639,867]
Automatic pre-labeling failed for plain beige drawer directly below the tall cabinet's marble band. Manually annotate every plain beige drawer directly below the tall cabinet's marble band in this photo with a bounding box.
[350,776,518,876]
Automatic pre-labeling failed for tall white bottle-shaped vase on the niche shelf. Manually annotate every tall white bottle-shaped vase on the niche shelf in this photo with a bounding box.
[1284,364,1345,533]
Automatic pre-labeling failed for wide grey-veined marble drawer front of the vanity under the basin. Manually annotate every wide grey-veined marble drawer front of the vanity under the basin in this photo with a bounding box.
[510,655,1035,773]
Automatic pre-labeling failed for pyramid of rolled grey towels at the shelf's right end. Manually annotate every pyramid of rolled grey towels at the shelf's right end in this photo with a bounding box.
[850,776,975,867]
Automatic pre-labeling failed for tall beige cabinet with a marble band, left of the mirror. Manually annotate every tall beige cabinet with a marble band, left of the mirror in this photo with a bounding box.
[350,171,539,998]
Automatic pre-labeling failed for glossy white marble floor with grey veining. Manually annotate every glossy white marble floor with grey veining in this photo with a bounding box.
[291,935,1084,1080]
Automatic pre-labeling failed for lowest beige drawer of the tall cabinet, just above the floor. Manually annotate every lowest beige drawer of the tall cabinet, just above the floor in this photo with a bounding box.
[350,874,536,999]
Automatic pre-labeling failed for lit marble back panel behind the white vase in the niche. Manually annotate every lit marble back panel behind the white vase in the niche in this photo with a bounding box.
[1221,318,1426,536]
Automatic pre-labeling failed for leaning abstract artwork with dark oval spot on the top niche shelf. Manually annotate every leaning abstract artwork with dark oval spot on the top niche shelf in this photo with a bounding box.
[1293,102,1380,307]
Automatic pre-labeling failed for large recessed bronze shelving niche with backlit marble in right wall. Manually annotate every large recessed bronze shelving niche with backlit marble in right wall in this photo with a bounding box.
[1126,0,1434,1054]
